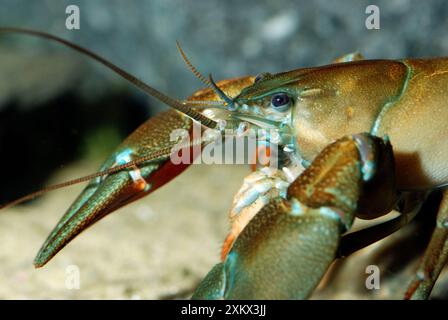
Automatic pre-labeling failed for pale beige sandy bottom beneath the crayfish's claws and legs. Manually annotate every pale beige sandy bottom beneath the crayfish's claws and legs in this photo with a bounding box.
[0,163,448,299]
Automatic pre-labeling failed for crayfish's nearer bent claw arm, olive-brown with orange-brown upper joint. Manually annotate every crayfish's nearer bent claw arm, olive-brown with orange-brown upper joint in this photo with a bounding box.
[193,134,395,299]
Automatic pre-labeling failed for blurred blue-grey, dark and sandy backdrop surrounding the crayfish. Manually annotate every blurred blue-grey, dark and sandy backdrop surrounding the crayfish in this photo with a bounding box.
[0,0,448,299]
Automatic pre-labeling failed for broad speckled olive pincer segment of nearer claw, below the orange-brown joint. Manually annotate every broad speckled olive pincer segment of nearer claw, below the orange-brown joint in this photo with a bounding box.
[193,198,340,299]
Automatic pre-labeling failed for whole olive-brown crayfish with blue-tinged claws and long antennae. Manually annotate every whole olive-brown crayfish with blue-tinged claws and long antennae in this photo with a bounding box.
[0,28,448,299]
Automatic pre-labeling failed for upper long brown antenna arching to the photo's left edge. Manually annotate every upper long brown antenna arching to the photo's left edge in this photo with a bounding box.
[0,27,217,129]
